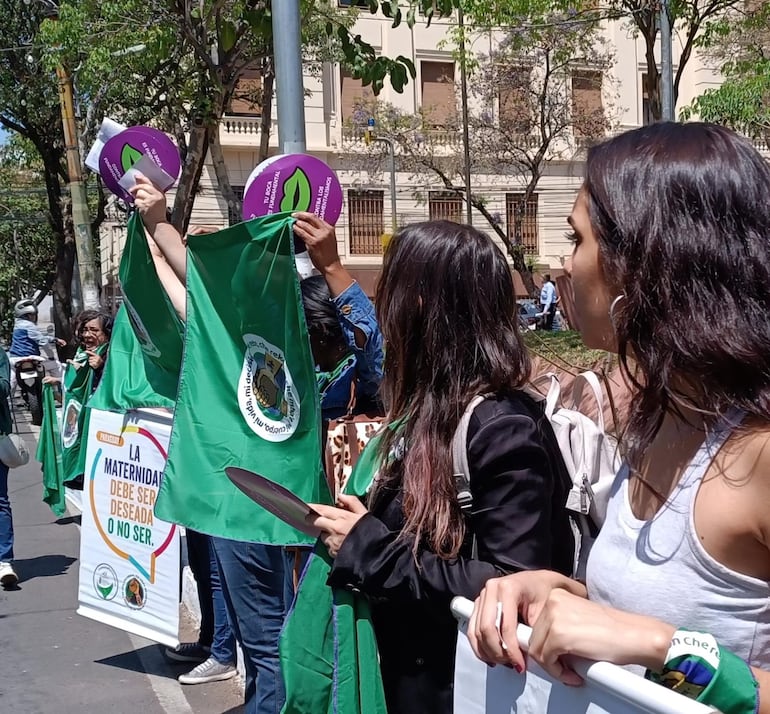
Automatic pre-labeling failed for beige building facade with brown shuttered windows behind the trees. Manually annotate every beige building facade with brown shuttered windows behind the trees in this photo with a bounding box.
[101,2,720,294]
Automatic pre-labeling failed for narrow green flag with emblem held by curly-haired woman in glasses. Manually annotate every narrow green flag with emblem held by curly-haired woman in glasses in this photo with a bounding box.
[61,343,107,483]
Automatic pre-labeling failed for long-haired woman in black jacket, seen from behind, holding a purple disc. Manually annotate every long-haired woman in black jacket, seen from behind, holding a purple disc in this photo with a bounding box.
[306,221,573,714]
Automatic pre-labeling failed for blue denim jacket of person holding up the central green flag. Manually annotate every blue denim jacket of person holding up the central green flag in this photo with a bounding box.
[319,282,384,421]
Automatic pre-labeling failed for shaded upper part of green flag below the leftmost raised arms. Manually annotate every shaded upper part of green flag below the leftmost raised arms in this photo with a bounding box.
[118,213,184,376]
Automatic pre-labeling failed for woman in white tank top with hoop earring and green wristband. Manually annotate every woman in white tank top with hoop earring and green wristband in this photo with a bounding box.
[469,123,770,714]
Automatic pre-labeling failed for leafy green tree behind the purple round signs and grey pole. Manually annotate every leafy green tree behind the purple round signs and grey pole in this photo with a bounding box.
[45,0,426,229]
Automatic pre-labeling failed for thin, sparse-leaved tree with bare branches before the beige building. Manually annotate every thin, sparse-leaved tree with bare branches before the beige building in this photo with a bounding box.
[348,8,613,292]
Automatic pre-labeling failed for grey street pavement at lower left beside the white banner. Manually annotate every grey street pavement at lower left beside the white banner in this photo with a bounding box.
[0,409,243,714]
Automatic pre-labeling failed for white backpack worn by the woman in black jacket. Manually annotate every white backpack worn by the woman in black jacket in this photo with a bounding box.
[452,372,621,579]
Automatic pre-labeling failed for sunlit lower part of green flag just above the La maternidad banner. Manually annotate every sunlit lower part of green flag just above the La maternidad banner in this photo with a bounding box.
[88,306,179,412]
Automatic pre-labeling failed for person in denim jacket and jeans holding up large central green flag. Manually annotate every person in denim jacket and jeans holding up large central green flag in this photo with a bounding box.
[133,177,383,714]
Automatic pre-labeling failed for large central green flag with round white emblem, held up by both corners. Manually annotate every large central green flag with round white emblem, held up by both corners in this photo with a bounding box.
[155,213,329,545]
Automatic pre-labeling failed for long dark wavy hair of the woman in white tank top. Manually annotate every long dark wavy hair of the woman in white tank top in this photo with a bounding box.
[584,123,770,469]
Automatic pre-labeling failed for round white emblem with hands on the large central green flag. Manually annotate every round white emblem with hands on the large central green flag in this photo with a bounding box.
[238,334,299,441]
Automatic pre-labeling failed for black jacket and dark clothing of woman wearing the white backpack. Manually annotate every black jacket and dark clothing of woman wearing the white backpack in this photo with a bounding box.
[329,392,574,714]
